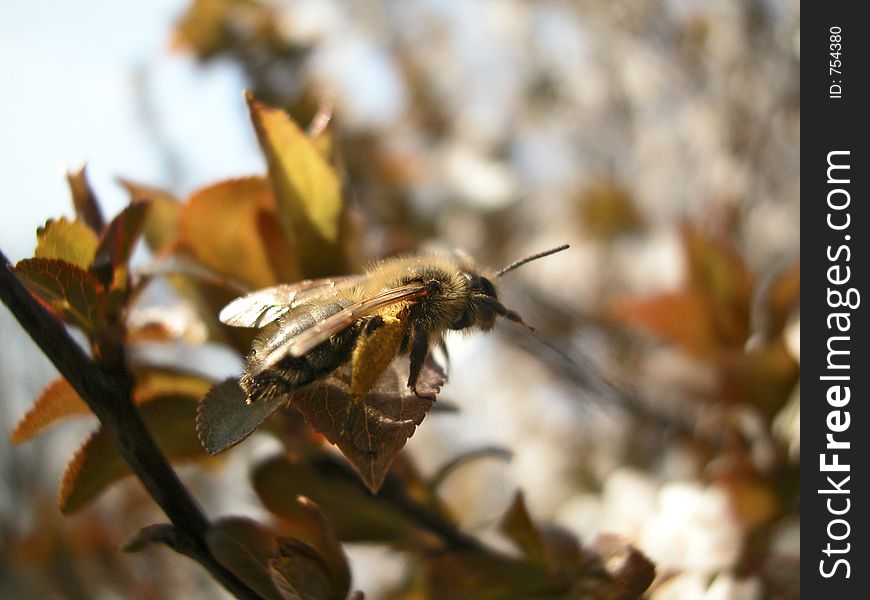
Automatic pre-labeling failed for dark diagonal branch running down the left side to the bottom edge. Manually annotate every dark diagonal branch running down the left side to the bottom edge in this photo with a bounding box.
[0,251,259,598]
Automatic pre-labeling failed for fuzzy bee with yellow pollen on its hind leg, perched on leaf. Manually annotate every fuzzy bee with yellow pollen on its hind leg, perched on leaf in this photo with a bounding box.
[219,245,568,404]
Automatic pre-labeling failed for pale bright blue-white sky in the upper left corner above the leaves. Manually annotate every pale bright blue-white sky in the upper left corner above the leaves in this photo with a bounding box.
[0,0,264,261]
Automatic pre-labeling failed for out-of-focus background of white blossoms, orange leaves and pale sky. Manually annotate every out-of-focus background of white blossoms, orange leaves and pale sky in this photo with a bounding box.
[0,0,800,600]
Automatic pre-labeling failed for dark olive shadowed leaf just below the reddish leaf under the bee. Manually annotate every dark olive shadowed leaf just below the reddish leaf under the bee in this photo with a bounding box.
[253,453,420,543]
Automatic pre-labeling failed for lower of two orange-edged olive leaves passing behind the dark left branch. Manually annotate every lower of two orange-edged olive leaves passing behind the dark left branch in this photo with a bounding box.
[58,396,206,515]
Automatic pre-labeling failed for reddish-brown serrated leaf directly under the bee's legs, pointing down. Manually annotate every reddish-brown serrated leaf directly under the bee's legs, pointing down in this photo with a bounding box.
[292,357,446,491]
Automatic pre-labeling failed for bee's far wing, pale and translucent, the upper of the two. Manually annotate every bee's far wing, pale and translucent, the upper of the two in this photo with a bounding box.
[218,275,365,327]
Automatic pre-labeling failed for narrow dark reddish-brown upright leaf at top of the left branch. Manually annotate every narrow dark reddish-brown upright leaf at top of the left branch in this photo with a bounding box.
[91,201,149,289]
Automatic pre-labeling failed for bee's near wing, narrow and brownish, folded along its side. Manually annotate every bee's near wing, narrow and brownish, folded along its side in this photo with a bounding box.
[254,283,427,374]
